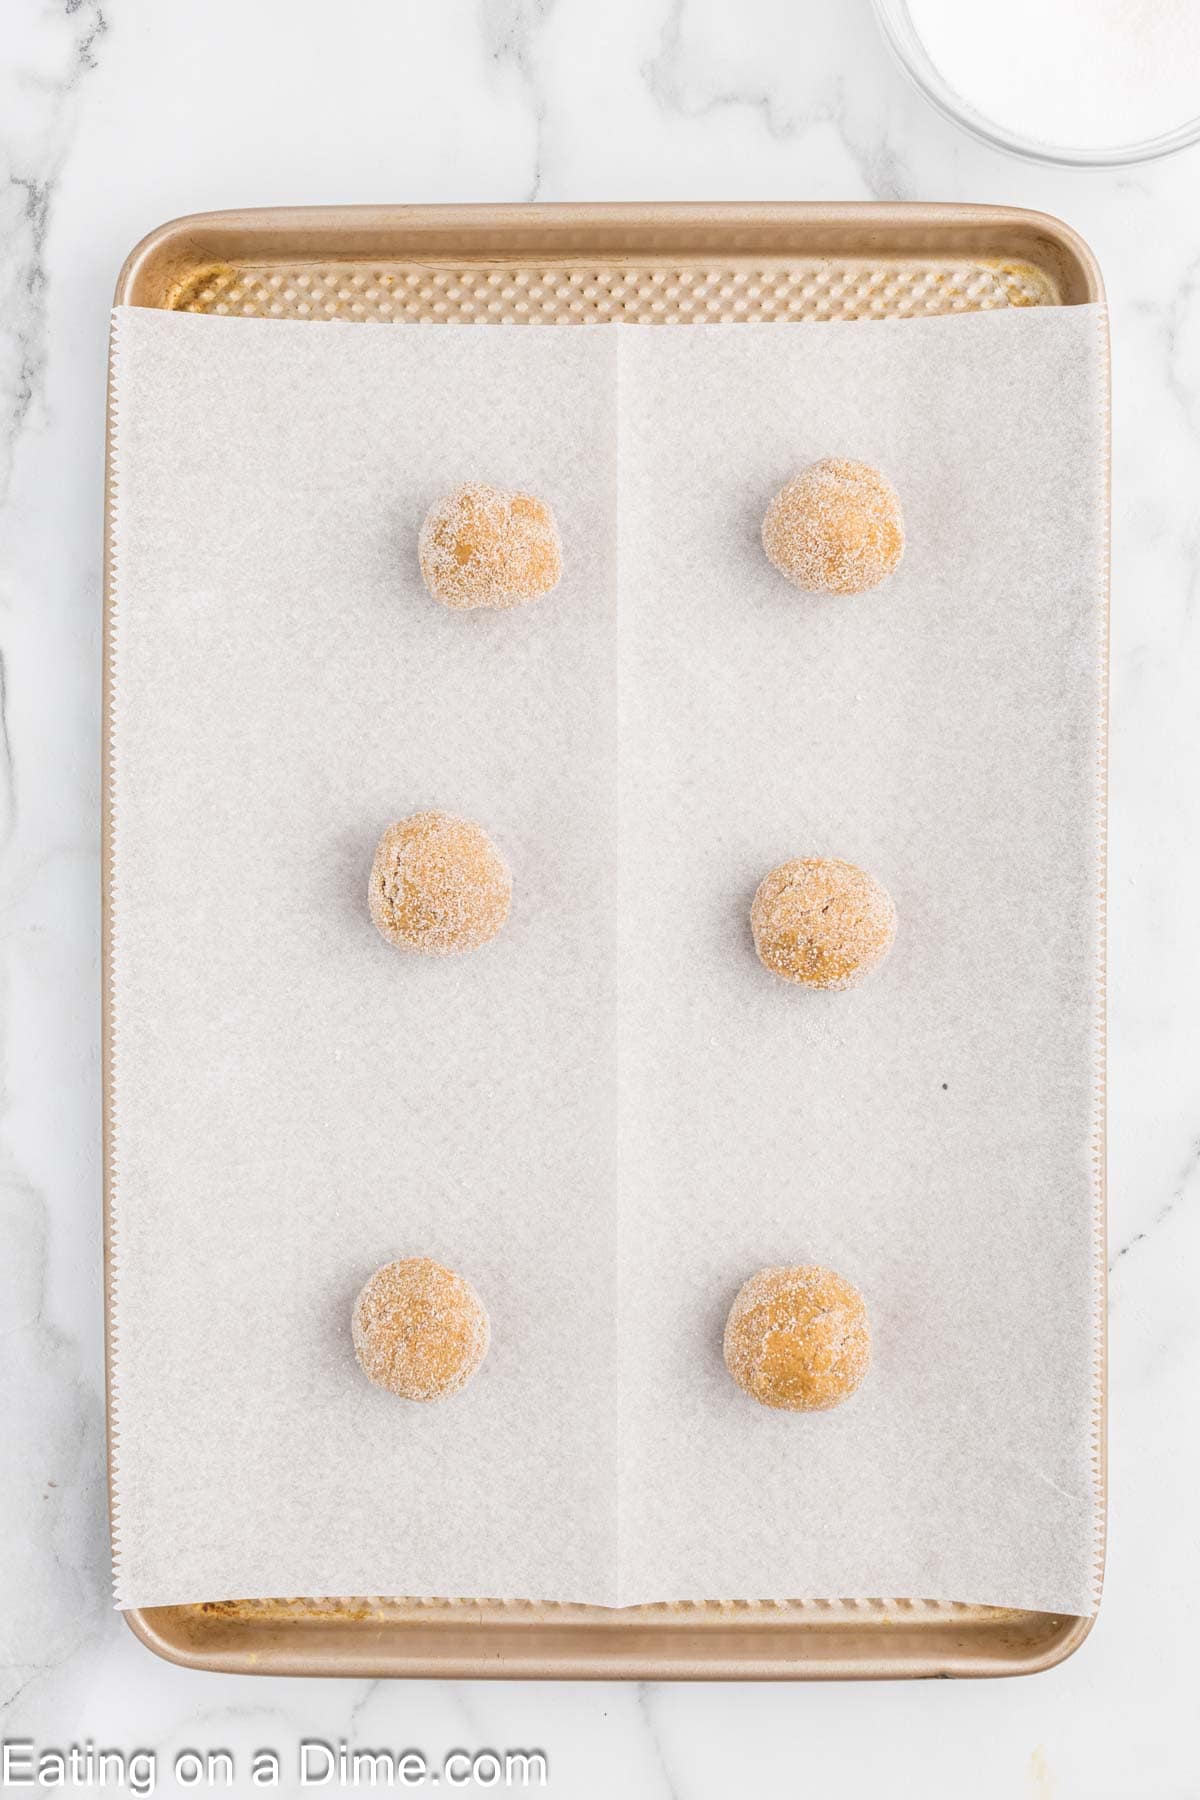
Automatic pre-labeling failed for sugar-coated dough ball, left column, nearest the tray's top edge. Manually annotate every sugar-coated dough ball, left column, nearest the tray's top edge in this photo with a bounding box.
[417,481,563,610]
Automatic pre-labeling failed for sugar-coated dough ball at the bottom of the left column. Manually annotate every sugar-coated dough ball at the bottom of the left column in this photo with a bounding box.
[351,1256,491,1400]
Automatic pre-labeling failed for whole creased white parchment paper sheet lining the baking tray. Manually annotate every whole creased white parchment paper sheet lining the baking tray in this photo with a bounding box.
[110,308,1105,1611]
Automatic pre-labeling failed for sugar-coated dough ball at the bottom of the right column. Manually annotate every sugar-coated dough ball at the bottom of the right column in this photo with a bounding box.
[725,1265,871,1413]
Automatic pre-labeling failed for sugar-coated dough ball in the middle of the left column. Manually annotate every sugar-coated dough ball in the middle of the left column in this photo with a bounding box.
[367,812,513,956]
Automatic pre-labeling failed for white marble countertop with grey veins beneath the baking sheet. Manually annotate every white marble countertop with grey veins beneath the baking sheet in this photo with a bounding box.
[0,0,1200,1800]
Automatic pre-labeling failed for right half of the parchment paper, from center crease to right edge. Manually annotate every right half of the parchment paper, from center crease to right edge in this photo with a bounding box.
[621,308,1105,1613]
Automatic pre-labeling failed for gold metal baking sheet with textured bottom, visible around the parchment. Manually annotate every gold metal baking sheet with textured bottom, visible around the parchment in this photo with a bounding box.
[103,203,1103,1679]
